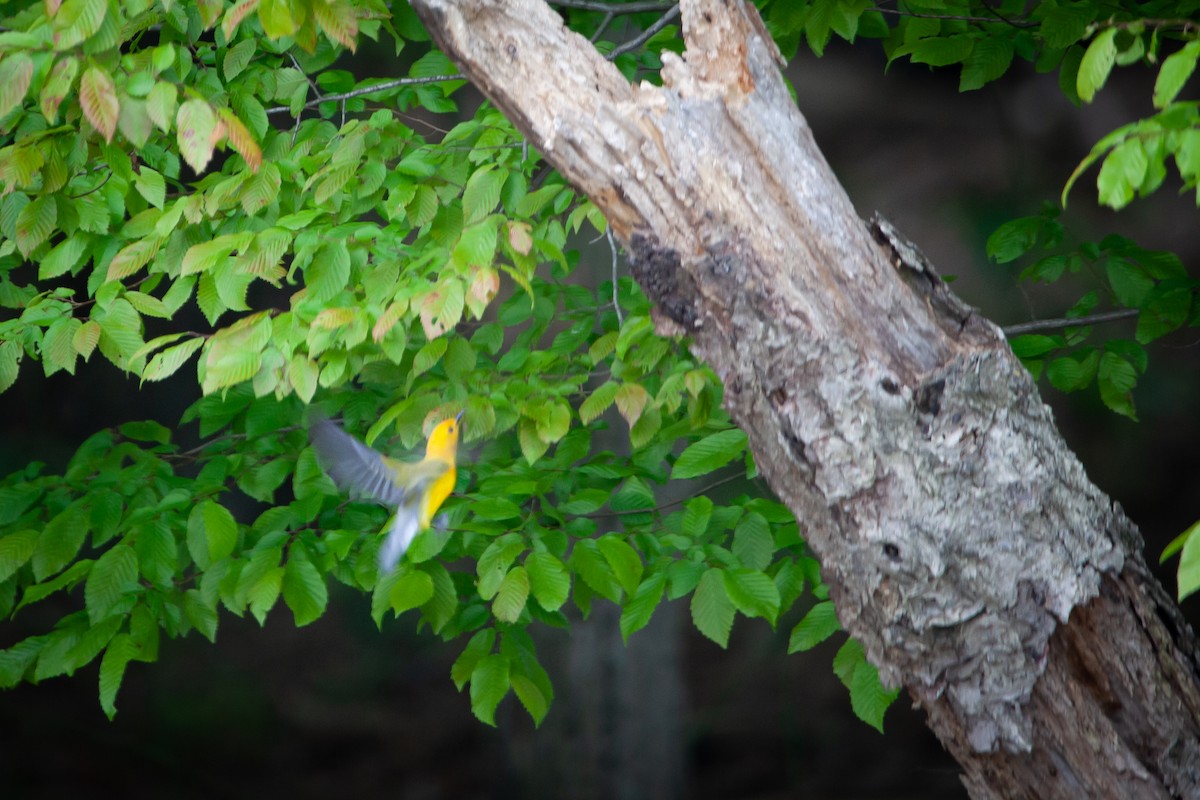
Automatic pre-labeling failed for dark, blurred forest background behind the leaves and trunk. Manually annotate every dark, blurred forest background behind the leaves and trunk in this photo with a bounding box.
[0,31,1200,800]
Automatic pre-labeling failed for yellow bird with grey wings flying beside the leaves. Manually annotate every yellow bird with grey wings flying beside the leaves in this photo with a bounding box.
[308,413,462,575]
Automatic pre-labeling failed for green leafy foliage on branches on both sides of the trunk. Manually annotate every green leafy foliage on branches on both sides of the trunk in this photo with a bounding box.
[0,0,1200,727]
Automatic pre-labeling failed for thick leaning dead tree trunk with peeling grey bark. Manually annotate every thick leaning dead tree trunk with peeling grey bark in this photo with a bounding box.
[412,0,1200,799]
